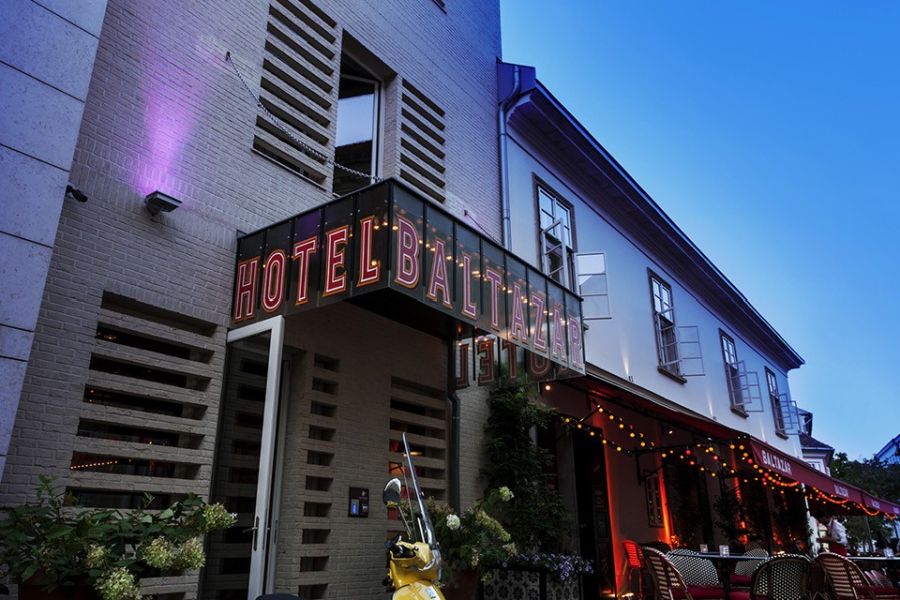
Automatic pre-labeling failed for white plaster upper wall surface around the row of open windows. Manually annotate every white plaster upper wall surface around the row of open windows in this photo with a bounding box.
[509,132,800,456]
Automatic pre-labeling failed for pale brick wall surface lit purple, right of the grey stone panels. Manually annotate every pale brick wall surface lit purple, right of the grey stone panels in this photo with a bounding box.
[0,0,500,582]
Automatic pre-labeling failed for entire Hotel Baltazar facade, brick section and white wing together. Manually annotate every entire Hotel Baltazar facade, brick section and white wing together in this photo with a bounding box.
[0,0,900,599]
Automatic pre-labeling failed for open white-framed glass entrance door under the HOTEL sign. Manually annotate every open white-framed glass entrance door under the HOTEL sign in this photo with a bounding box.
[202,316,284,600]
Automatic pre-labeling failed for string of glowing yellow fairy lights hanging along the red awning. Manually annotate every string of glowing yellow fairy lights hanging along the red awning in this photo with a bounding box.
[558,404,896,520]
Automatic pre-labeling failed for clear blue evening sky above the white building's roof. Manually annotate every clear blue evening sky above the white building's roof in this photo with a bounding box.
[501,0,900,458]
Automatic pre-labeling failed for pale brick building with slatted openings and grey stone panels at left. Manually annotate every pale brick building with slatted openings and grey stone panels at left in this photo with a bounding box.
[0,0,500,598]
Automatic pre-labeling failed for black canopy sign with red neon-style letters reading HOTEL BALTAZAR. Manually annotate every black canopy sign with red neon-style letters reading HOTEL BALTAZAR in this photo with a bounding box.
[231,181,584,374]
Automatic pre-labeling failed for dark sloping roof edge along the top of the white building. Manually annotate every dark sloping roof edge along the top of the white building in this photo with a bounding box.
[503,63,806,368]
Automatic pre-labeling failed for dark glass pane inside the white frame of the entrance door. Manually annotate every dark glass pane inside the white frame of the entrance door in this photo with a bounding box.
[202,332,271,600]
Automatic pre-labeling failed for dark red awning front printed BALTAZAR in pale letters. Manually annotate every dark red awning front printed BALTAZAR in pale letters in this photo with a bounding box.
[750,437,900,517]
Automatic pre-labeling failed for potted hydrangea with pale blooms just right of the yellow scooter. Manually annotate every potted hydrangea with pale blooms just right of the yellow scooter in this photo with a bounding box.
[428,487,518,600]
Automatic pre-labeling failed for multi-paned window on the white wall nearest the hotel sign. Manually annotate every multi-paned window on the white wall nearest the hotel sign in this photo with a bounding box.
[537,186,575,289]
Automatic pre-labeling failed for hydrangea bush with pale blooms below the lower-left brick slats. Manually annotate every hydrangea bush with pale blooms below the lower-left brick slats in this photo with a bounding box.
[0,477,235,600]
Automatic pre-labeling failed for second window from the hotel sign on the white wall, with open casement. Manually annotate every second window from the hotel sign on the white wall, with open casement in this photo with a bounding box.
[650,272,704,378]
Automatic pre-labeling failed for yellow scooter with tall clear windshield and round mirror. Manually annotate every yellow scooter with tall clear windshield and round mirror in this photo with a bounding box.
[381,433,444,600]
